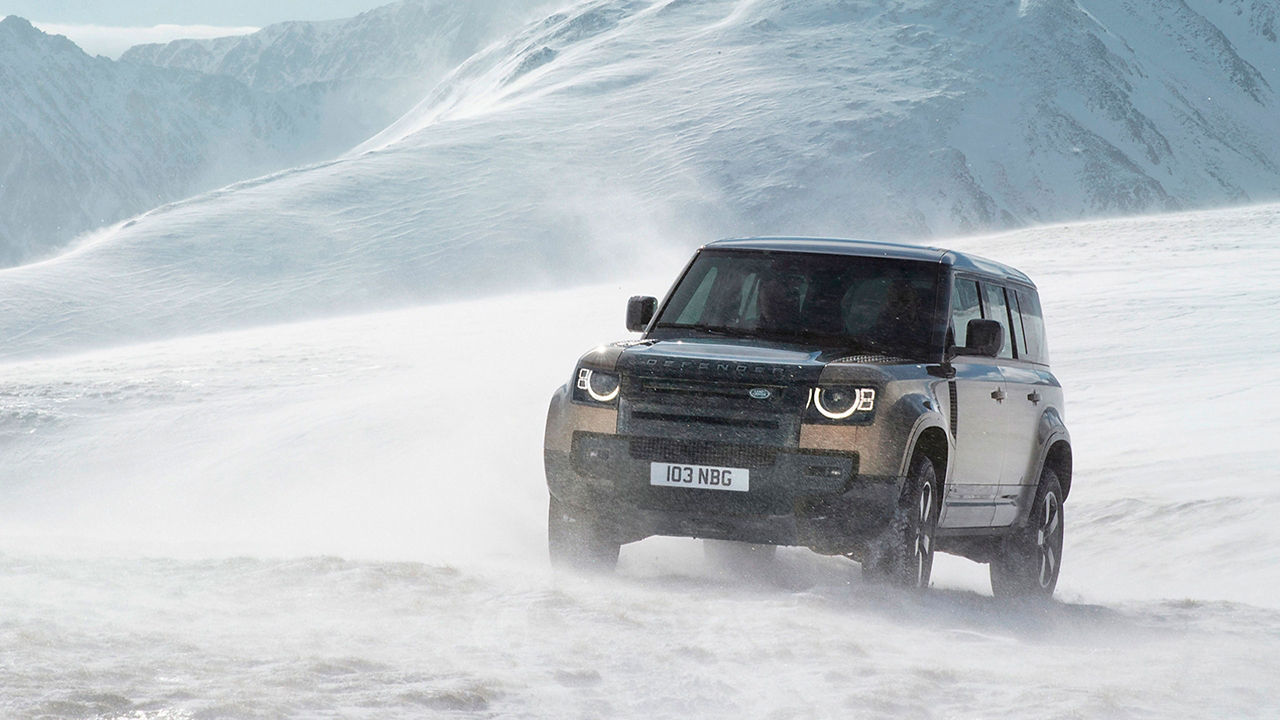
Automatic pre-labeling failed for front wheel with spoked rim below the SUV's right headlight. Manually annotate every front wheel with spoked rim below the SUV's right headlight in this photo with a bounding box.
[863,455,941,591]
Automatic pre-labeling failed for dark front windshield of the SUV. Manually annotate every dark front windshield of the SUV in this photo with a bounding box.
[655,250,938,357]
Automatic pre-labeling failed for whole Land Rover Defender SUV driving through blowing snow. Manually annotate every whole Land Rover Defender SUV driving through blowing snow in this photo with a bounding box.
[544,237,1071,597]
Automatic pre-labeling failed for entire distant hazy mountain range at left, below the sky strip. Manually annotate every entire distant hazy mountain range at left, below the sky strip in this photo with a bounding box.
[0,0,545,266]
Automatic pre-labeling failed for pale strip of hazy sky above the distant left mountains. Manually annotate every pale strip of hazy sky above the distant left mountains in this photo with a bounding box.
[0,0,392,59]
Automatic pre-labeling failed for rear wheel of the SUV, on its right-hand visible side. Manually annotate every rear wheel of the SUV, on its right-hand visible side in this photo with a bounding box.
[991,468,1065,600]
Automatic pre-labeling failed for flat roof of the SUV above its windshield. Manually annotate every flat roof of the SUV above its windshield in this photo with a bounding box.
[703,237,1034,287]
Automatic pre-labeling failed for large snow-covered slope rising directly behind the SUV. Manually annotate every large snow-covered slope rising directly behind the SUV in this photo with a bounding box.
[0,0,1280,354]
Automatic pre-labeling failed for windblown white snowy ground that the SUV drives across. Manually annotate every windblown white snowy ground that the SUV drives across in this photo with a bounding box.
[0,206,1280,719]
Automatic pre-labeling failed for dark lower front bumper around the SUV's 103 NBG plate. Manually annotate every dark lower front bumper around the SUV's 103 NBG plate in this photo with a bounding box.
[545,430,902,553]
